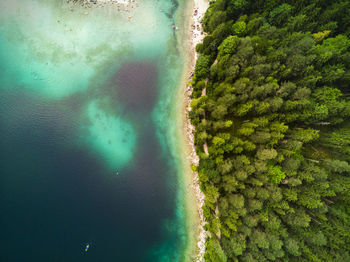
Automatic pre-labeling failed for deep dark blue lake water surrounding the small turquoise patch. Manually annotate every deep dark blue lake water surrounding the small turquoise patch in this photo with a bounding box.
[0,58,183,261]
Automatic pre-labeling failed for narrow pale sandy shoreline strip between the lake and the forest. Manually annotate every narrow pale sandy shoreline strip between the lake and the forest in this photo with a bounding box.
[184,0,209,262]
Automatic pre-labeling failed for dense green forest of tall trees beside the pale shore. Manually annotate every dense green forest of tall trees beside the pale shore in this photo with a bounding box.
[189,0,350,262]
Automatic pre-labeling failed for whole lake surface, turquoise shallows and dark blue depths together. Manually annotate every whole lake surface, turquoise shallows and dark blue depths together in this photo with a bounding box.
[0,0,189,261]
